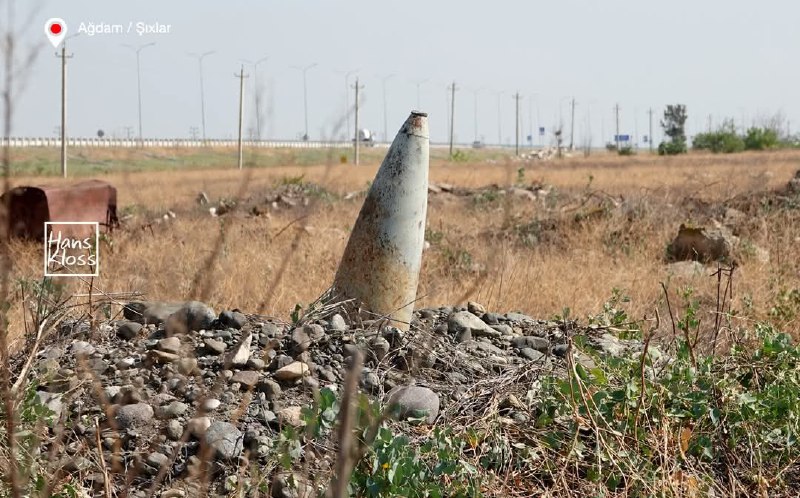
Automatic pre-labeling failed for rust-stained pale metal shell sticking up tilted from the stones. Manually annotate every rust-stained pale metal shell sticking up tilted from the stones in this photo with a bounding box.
[333,112,429,330]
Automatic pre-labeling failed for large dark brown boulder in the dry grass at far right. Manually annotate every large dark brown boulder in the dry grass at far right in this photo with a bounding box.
[667,224,737,262]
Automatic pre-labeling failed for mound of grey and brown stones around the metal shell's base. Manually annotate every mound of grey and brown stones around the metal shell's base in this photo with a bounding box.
[15,302,641,497]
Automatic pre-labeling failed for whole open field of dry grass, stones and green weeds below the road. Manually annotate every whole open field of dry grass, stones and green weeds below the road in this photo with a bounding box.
[0,146,800,498]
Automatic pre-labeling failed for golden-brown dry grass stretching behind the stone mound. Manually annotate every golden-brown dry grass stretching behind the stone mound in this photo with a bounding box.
[6,151,800,346]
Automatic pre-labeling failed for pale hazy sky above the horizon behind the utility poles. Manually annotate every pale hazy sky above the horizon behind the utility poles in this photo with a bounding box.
[0,0,800,146]
